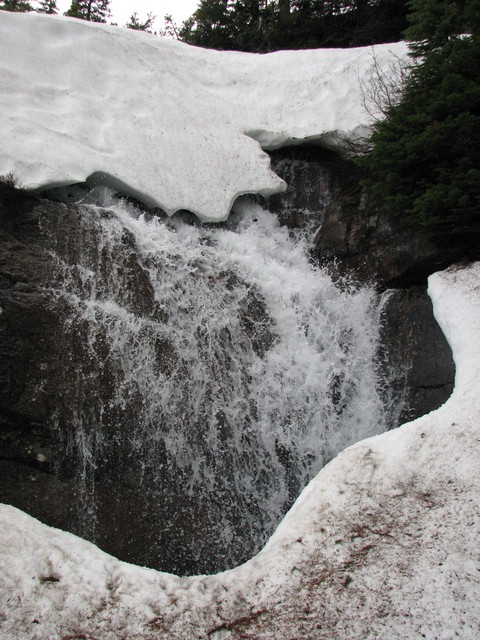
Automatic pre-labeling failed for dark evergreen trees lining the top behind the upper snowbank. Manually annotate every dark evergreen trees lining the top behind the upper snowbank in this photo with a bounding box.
[180,0,407,51]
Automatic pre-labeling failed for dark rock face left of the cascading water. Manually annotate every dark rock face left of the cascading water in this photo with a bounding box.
[0,185,84,556]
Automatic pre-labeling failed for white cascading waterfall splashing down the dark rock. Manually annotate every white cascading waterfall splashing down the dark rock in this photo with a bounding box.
[38,193,385,574]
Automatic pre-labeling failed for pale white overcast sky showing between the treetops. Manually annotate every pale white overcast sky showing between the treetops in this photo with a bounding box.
[57,0,200,29]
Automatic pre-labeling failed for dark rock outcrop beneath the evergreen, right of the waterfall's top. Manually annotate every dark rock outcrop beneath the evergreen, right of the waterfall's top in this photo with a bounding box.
[268,147,478,288]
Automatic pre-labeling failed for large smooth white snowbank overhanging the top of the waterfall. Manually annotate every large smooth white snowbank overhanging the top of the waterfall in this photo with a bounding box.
[0,11,406,221]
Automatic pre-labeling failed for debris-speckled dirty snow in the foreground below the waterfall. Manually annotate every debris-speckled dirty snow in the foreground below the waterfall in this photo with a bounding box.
[0,263,480,640]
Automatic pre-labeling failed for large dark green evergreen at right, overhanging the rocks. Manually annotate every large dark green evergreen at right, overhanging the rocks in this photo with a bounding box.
[361,0,480,234]
